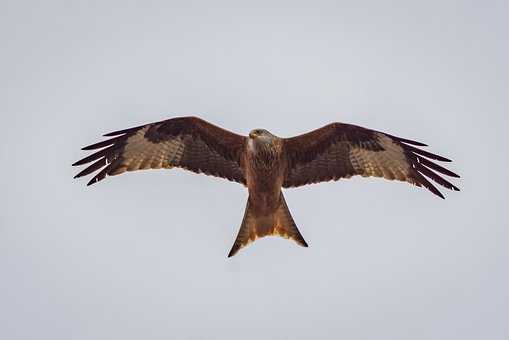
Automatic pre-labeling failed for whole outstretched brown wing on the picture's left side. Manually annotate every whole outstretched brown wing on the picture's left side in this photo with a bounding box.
[73,117,246,185]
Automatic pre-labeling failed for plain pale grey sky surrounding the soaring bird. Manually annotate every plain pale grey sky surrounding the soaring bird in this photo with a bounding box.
[0,0,509,340]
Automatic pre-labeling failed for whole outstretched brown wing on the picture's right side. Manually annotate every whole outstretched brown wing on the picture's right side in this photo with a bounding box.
[283,123,459,198]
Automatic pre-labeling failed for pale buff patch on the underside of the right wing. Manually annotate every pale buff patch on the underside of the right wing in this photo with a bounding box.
[349,133,410,181]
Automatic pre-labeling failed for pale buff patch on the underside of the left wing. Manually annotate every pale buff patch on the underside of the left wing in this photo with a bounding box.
[110,126,184,175]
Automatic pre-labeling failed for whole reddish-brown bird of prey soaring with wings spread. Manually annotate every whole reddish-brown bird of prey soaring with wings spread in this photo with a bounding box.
[73,117,459,257]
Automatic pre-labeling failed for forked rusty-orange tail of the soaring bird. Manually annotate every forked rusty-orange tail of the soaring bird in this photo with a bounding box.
[228,193,308,257]
